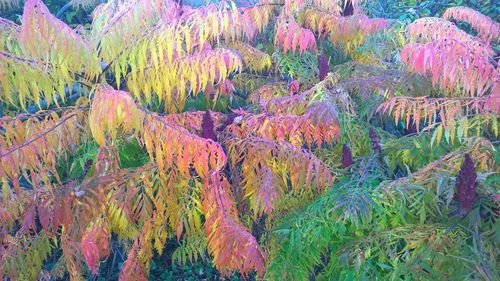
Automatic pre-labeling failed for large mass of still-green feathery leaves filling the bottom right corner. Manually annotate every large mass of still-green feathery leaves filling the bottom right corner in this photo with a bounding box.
[267,154,498,280]
